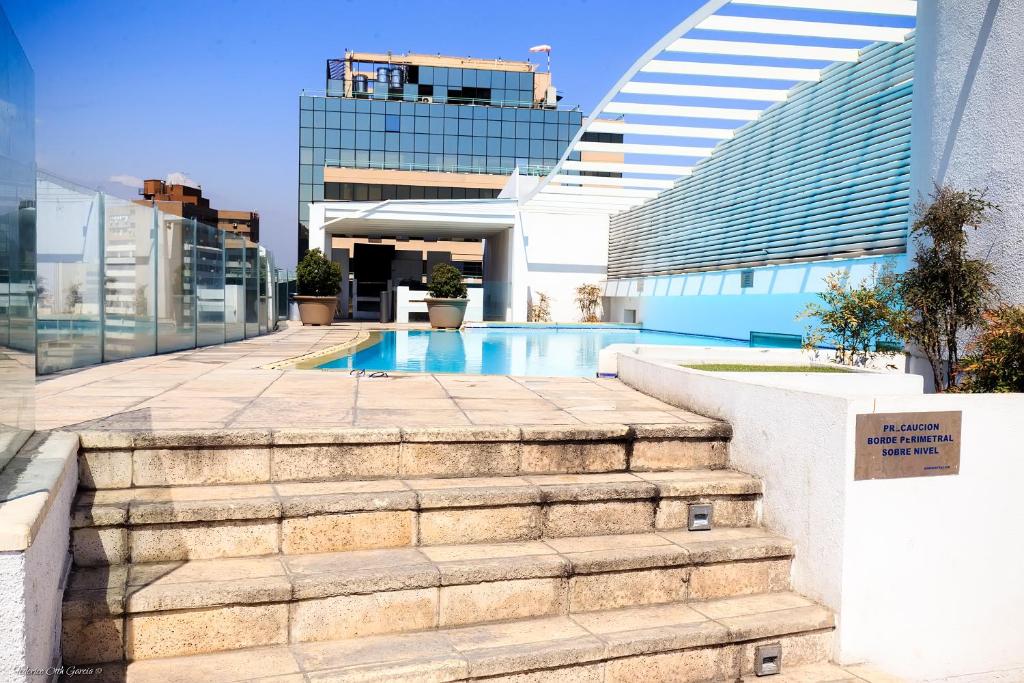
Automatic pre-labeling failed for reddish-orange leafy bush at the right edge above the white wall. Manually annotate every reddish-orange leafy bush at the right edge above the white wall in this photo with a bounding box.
[959,306,1024,392]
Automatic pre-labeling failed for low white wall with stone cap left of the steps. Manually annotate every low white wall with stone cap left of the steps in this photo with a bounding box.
[0,433,78,683]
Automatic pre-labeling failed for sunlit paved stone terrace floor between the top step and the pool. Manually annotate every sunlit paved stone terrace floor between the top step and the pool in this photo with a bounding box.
[36,324,708,430]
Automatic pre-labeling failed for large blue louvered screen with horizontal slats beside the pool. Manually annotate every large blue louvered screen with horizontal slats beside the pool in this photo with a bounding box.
[608,36,913,279]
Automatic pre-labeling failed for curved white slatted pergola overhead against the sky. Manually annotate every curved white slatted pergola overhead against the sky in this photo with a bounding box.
[522,0,918,215]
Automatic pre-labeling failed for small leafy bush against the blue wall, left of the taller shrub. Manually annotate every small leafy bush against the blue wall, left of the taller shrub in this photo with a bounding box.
[797,263,902,365]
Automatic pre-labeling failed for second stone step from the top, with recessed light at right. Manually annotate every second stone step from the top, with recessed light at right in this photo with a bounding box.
[72,470,762,566]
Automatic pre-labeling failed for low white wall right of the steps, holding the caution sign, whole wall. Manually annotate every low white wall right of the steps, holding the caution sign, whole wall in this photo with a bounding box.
[618,354,1024,680]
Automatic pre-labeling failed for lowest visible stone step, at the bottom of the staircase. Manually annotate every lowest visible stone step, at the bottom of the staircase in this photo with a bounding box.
[112,592,842,683]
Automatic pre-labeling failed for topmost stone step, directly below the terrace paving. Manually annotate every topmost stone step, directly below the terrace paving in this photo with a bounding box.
[80,418,732,488]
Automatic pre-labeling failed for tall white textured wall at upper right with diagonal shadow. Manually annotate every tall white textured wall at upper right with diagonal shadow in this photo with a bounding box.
[910,0,1024,304]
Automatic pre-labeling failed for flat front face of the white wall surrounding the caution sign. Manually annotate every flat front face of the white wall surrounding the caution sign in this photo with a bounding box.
[842,394,1024,680]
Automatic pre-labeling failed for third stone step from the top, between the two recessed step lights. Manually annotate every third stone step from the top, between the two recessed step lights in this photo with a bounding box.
[63,528,793,664]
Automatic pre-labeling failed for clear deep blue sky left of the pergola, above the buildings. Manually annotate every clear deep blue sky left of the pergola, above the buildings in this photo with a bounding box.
[3,0,700,265]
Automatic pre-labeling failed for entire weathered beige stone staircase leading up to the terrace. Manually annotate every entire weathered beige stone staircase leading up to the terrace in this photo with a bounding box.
[62,420,834,683]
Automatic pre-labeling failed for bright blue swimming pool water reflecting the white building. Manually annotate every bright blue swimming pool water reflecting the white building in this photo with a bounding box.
[311,328,748,377]
